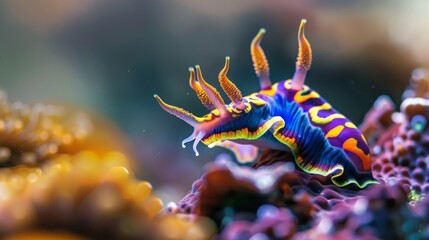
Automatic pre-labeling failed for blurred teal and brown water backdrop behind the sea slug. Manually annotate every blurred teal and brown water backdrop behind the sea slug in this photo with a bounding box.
[0,0,429,215]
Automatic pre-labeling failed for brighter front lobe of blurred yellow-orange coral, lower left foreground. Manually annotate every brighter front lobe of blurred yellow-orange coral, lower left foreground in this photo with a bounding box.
[0,151,162,236]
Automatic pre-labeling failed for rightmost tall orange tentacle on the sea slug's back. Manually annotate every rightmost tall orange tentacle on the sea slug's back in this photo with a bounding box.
[291,19,312,89]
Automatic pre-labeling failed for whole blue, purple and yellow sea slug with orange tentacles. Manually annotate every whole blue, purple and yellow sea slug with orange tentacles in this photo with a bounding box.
[154,20,376,188]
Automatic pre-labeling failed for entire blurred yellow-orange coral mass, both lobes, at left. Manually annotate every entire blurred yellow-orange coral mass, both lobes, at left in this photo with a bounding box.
[0,91,214,239]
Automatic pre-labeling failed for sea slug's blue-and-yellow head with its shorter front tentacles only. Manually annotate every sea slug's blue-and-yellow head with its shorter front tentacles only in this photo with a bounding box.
[154,57,274,156]
